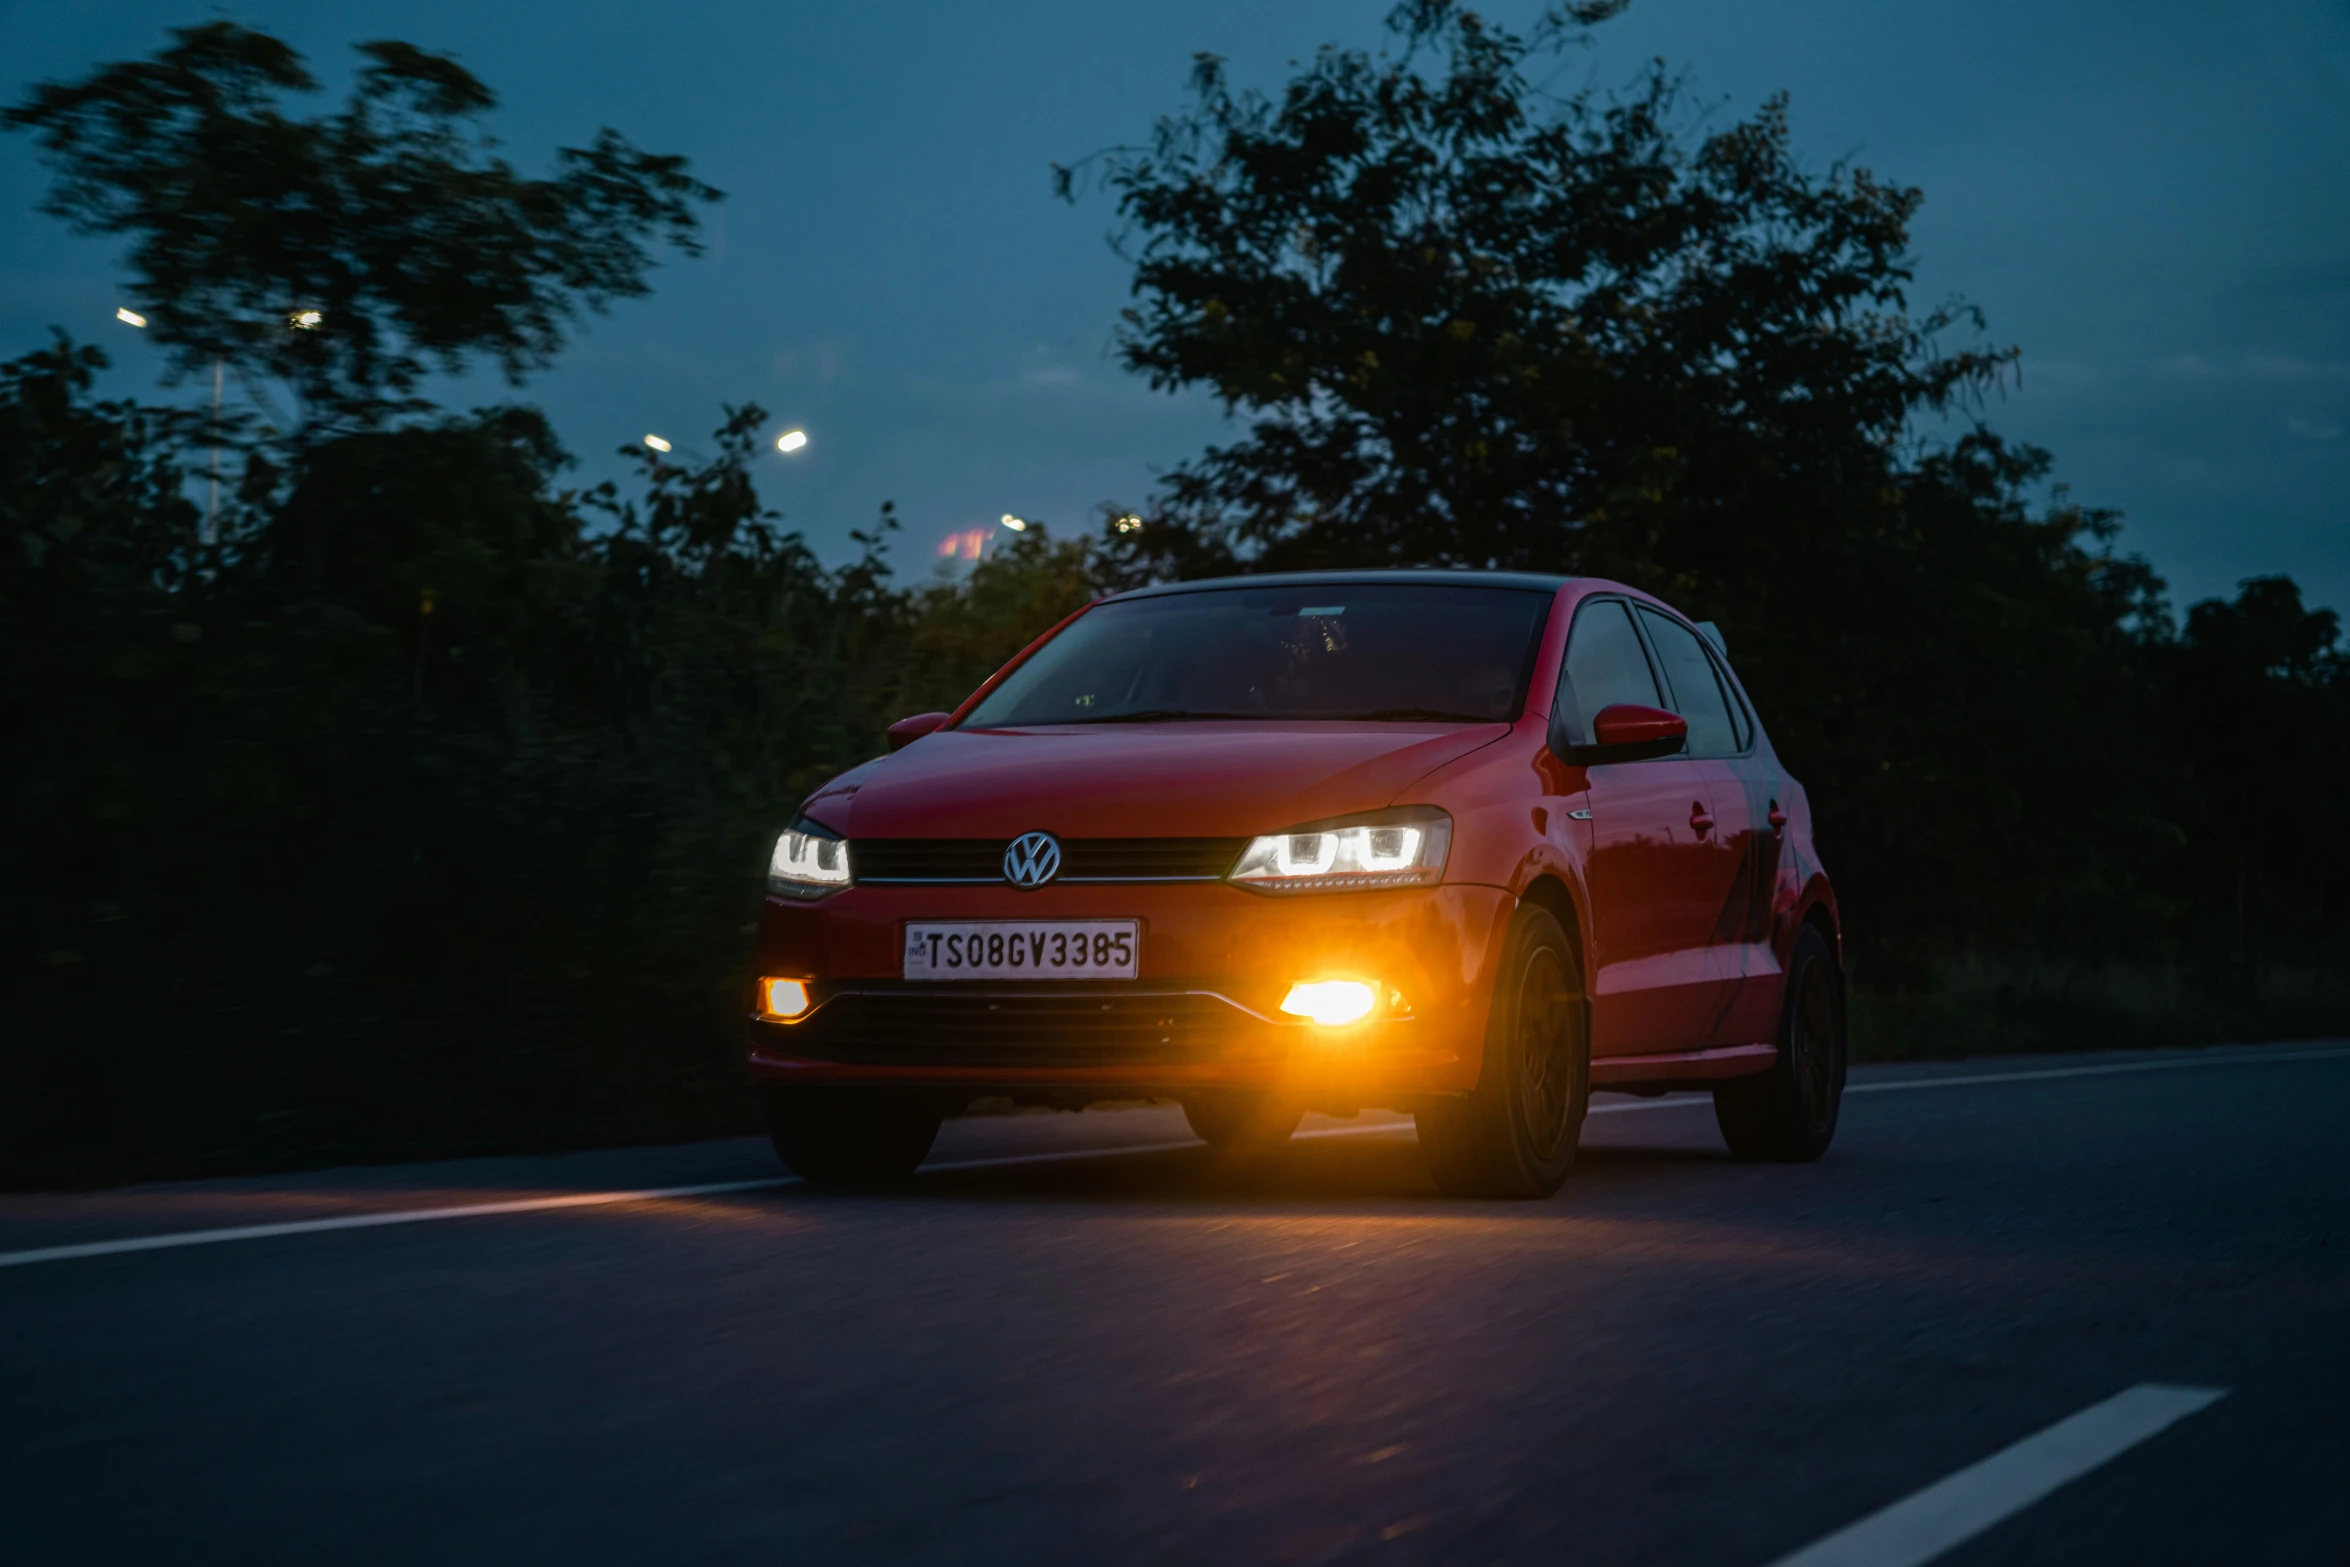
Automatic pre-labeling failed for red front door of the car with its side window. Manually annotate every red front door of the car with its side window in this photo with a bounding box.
[1563,599,1723,1057]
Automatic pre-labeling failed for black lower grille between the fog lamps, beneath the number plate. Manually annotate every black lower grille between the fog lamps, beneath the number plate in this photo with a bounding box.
[776,987,1295,1067]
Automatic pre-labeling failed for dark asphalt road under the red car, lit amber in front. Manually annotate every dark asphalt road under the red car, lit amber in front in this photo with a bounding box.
[0,1045,2350,1567]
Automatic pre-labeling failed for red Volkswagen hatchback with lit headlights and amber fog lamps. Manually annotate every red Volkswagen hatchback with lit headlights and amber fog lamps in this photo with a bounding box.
[750,571,1845,1196]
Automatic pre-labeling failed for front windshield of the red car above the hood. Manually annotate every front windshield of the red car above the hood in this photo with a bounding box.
[964,583,1551,728]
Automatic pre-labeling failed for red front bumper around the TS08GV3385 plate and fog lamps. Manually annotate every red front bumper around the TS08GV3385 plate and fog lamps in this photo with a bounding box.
[750,883,1511,1104]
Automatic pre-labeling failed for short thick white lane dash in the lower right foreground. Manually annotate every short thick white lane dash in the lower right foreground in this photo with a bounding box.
[1772,1381,2228,1567]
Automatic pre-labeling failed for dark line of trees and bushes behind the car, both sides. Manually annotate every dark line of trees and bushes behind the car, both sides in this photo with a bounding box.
[0,0,2350,1182]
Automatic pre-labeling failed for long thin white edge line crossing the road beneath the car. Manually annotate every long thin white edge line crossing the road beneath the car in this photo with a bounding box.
[0,1045,2350,1269]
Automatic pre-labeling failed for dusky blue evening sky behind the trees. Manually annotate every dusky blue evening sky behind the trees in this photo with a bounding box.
[0,0,2350,608]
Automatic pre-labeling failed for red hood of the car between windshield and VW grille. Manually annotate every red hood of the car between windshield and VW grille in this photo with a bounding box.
[806,721,1509,839]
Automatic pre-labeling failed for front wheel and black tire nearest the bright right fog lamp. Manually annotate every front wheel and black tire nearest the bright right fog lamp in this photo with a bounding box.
[1415,904,1591,1198]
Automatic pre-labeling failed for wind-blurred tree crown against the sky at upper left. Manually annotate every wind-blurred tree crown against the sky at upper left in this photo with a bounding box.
[0,21,719,432]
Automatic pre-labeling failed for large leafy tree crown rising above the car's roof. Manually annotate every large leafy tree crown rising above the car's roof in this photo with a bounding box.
[1060,0,2012,587]
